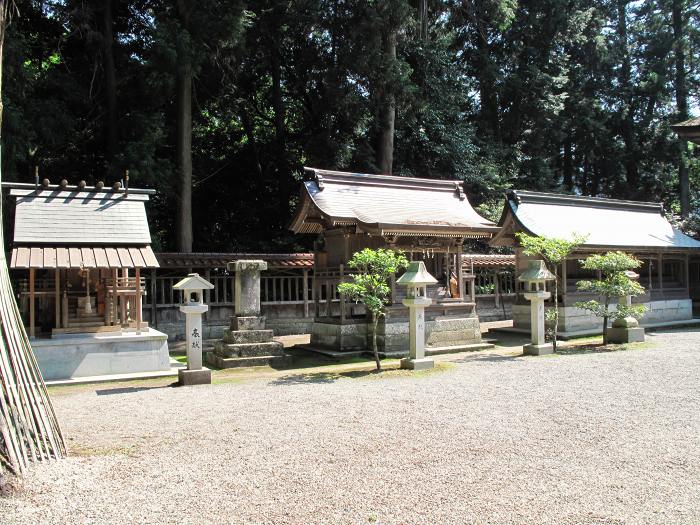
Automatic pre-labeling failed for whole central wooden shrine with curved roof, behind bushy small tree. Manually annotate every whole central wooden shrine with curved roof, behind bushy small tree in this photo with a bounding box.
[290,168,498,353]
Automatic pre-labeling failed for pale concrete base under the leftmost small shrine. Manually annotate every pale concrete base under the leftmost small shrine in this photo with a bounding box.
[30,328,170,381]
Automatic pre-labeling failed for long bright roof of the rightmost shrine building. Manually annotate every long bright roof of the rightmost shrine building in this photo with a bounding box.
[491,190,700,249]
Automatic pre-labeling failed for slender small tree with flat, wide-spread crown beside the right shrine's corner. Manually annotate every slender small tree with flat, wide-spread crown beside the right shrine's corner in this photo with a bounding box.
[515,232,587,351]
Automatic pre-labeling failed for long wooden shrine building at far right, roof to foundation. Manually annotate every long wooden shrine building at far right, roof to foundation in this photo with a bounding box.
[490,190,700,335]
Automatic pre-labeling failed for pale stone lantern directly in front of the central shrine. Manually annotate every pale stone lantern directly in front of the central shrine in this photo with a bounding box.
[396,261,437,370]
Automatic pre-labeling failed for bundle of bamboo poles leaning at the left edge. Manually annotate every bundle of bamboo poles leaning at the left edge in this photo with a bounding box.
[0,0,66,474]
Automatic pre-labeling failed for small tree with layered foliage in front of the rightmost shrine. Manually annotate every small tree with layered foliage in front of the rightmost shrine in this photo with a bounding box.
[575,252,646,345]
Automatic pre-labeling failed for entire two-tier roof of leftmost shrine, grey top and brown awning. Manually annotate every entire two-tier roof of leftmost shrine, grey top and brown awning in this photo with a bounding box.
[3,183,158,268]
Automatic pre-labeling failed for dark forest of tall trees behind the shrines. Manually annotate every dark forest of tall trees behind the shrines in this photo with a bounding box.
[2,0,700,252]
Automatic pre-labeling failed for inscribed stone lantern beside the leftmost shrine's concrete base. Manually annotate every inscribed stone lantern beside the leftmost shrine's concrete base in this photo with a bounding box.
[173,273,214,385]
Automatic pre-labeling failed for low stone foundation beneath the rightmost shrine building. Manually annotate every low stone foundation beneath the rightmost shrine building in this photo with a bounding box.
[513,299,693,333]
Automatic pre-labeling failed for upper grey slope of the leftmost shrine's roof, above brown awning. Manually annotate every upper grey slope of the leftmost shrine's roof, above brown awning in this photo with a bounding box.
[11,190,151,246]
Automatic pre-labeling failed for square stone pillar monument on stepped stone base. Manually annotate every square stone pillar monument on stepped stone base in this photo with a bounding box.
[209,260,291,368]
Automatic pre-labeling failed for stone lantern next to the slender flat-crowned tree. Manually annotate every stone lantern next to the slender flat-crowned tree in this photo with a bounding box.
[518,261,555,355]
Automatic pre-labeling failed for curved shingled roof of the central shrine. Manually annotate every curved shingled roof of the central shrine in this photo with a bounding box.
[290,168,498,237]
